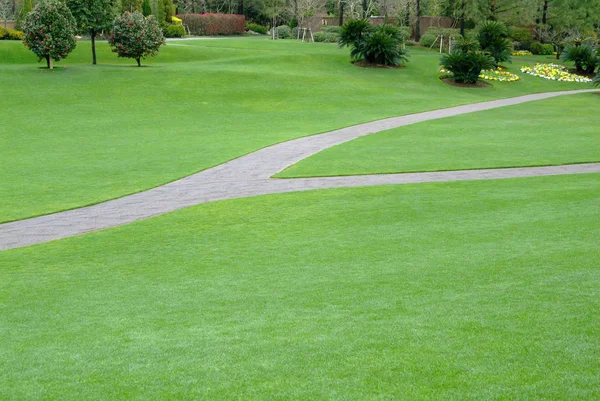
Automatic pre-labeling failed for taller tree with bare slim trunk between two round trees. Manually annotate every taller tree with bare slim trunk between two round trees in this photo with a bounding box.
[67,0,120,64]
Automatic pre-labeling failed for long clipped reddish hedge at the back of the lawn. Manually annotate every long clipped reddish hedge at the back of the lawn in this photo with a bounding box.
[177,14,246,36]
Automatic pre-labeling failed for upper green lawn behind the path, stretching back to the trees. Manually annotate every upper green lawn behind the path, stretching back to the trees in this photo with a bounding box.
[0,38,589,222]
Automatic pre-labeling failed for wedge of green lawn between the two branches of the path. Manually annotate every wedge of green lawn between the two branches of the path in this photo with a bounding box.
[277,94,600,178]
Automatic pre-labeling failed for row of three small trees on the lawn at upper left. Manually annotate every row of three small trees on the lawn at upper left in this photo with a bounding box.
[23,0,164,69]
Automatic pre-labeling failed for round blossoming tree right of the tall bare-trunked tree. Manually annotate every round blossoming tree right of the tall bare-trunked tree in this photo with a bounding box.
[108,11,165,67]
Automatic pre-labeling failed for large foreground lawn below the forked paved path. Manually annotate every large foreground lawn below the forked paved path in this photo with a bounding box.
[0,174,600,400]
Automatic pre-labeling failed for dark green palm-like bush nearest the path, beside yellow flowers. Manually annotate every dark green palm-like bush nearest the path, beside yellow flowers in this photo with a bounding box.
[440,50,495,84]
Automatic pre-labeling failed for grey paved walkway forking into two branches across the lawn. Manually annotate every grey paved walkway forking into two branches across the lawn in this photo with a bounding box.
[0,89,600,250]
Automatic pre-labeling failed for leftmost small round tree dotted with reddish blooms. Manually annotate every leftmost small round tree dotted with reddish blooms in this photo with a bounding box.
[23,0,77,69]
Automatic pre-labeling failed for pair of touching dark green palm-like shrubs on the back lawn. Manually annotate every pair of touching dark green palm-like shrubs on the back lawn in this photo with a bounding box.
[338,20,408,66]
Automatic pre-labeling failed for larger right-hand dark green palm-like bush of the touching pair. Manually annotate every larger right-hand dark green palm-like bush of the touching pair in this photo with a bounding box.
[352,25,408,66]
